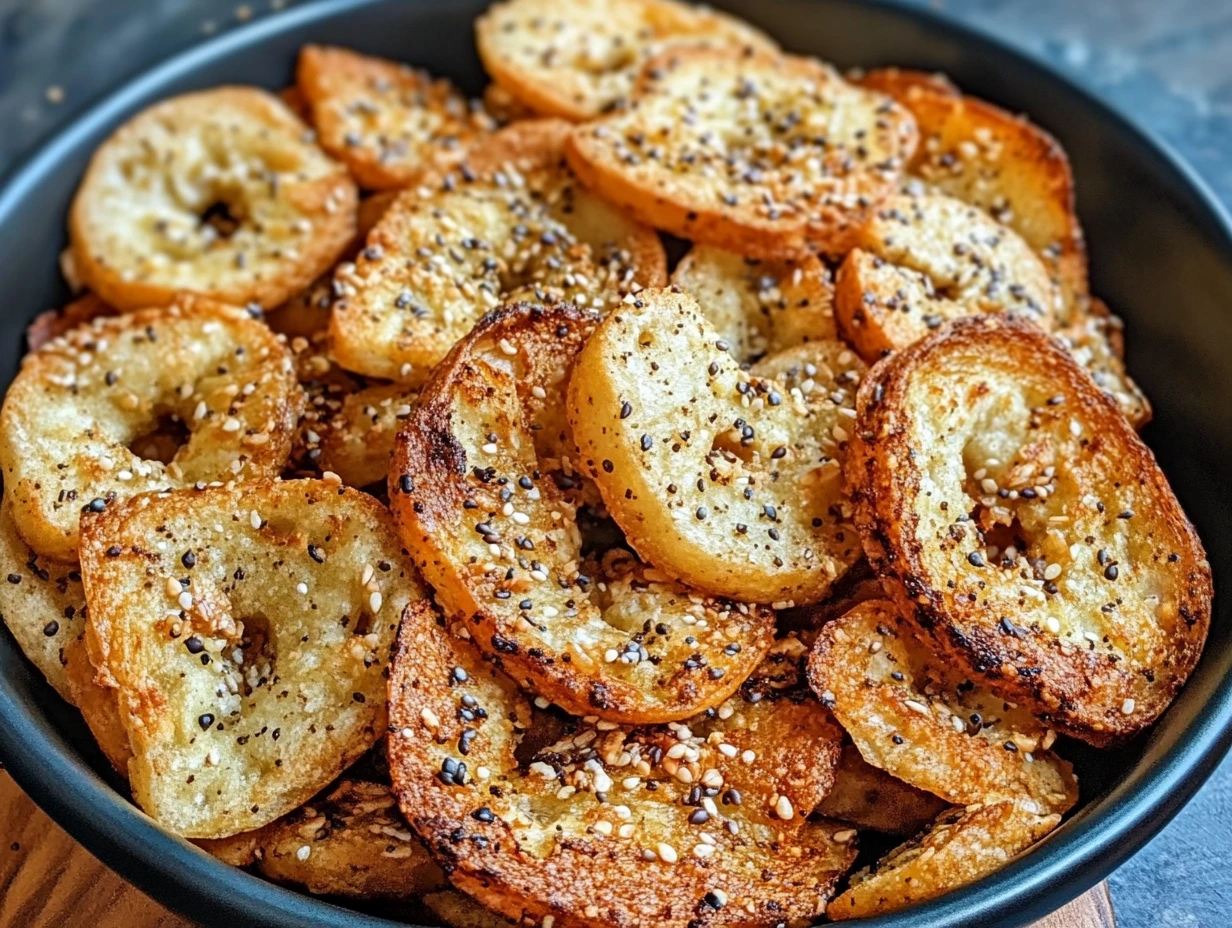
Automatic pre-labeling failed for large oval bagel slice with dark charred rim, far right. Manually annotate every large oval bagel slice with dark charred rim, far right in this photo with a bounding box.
[845,314,1211,744]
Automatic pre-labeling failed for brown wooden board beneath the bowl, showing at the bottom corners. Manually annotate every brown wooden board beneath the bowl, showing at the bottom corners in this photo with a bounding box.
[0,771,1116,928]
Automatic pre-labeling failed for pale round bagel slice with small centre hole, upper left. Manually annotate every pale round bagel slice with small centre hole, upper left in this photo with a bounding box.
[69,88,357,309]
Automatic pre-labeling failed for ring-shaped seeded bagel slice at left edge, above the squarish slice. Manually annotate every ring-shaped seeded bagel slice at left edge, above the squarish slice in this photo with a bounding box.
[0,297,303,561]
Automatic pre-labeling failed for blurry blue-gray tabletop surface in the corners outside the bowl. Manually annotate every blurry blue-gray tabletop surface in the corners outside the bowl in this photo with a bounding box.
[0,0,1232,928]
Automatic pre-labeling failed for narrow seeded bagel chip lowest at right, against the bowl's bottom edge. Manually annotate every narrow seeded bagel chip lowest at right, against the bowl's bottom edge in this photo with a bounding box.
[825,801,1061,922]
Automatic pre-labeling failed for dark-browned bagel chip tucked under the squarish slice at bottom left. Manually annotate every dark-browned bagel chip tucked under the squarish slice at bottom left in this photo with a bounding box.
[197,779,446,900]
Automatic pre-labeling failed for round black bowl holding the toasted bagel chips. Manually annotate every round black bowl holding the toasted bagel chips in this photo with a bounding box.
[0,0,1232,928]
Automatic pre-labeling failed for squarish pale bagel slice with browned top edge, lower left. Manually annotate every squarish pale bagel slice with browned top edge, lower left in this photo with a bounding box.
[81,481,424,838]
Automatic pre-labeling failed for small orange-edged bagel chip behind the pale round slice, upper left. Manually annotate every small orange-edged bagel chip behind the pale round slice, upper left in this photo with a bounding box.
[296,46,495,190]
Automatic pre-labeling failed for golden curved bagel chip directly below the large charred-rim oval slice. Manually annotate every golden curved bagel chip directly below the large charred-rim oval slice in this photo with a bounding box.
[808,600,1078,812]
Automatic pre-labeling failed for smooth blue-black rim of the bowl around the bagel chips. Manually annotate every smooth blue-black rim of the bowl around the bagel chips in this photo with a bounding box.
[0,0,1232,928]
